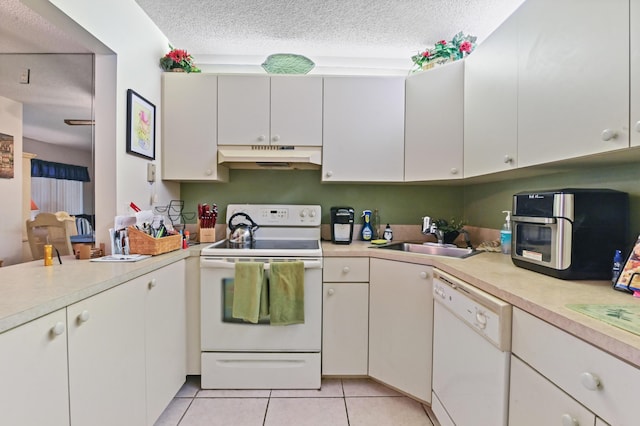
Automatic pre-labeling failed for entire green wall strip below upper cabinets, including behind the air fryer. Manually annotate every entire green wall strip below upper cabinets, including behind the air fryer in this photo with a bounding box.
[181,164,640,238]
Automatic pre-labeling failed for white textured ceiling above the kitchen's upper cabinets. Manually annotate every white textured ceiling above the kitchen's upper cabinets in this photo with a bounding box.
[136,0,523,70]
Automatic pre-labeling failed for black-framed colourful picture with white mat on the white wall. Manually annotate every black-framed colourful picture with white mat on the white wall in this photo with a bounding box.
[127,89,156,160]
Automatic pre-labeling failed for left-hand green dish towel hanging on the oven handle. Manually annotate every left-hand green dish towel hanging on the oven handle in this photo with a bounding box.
[231,262,268,324]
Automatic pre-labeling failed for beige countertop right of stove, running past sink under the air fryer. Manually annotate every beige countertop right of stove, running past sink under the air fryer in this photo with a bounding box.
[322,241,640,368]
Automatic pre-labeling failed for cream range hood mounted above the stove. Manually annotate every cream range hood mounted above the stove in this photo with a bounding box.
[218,145,322,170]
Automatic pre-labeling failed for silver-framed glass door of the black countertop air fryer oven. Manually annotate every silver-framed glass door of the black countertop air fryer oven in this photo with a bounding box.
[511,216,572,270]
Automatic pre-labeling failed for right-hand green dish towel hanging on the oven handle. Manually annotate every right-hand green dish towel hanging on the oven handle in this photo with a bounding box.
[269,262,304,325]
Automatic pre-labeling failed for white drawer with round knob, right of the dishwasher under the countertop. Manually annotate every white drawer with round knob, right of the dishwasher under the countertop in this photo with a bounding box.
[512,309,640,425]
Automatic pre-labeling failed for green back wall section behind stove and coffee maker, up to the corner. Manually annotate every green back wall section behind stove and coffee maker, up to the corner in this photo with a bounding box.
[180,170,464,225]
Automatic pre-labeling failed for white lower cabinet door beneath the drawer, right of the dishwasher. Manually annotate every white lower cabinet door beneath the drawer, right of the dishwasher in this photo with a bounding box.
[509,355,595,426]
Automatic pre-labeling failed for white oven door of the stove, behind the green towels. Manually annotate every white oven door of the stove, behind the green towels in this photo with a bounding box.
[200,256,322,352]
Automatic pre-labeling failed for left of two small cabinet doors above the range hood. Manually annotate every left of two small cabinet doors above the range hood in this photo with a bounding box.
[218,75,269,145]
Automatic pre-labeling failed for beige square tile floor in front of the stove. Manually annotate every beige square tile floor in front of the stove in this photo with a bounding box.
[156,376,438,426]
